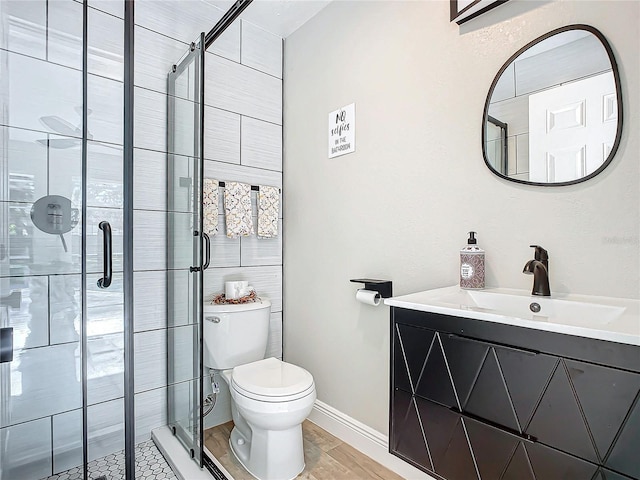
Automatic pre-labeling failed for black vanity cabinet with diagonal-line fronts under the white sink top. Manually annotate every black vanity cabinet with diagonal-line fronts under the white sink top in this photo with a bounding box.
[389,307,640,480]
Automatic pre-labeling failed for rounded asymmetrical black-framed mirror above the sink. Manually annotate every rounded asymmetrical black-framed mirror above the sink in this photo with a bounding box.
[482,25,622,185]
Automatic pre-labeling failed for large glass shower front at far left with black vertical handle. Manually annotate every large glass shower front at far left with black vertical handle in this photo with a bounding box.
[0,0,130,480]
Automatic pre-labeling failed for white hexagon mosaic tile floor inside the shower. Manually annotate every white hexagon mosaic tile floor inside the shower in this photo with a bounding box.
[44,440,176,480]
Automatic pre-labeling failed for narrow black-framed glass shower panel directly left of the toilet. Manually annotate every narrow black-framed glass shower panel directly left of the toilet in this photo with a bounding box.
[167,34,209,466]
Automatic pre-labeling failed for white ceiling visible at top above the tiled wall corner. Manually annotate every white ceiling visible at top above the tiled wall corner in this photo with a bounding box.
[206,0,332,38]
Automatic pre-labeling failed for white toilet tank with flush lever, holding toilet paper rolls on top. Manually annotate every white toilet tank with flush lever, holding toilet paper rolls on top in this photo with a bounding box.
[204,298,271,370]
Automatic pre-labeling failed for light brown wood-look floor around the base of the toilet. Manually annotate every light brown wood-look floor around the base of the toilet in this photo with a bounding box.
[204,420,402,480]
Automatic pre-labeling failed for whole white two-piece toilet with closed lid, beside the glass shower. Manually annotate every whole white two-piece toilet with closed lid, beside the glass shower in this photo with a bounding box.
[204,298,316,480]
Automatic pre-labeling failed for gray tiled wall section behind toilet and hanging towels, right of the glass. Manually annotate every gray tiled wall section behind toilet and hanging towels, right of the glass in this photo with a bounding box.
[199,21,283,428]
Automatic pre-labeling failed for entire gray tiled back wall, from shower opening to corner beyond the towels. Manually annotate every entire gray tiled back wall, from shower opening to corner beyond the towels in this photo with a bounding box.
[134,1,282,441]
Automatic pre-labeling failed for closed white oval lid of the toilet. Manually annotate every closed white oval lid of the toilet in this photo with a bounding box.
[232,358,313,400]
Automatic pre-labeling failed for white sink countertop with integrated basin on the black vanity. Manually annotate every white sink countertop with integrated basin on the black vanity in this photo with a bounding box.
[384,285,640,346]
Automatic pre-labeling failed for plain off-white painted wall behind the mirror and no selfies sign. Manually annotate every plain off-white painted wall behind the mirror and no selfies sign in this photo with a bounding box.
[284,1,640,432]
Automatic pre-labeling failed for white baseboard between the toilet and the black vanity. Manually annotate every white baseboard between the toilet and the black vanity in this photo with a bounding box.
[309,400,435,480]
